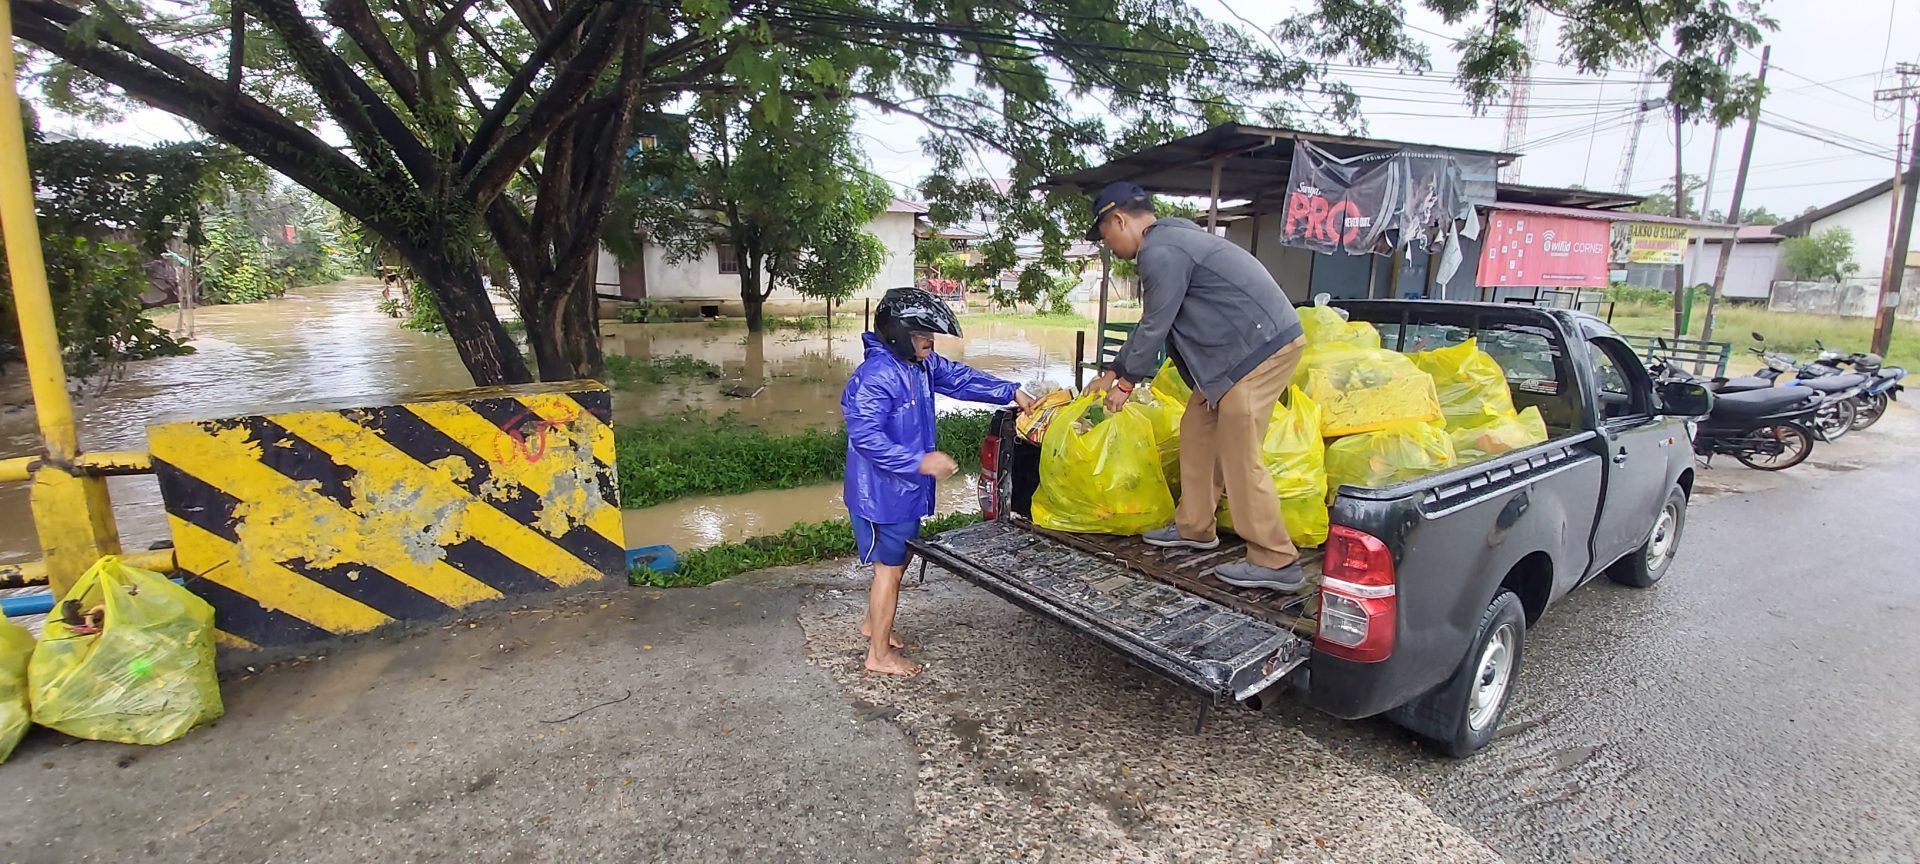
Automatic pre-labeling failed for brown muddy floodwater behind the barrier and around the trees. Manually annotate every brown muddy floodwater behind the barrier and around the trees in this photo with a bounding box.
[0,282,1073,561]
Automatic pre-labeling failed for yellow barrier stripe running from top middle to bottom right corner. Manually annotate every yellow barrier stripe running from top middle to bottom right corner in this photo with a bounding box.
[275,411,603,586]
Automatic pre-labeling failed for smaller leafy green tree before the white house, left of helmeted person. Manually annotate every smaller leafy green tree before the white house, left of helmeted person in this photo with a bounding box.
[607,96,893,330]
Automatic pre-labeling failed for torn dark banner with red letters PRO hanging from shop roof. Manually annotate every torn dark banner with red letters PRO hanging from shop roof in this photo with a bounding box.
[1281,140,1496,280]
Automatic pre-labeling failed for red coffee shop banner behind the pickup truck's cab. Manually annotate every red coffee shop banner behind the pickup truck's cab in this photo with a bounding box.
[1475,209,1609,288]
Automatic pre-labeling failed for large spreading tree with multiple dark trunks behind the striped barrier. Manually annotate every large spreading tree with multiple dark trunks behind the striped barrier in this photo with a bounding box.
[12,0,1772,384]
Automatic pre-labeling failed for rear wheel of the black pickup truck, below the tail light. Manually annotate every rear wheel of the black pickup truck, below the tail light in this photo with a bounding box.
[1386,591,1526,758]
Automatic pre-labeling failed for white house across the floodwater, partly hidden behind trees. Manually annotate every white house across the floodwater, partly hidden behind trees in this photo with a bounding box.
[593,198,927,315]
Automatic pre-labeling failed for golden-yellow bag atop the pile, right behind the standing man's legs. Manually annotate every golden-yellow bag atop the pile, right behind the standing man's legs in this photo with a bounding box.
[1294,346,1442,438]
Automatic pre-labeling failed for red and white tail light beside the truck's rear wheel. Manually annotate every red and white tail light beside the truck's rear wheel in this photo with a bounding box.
[1313,524,1400,662]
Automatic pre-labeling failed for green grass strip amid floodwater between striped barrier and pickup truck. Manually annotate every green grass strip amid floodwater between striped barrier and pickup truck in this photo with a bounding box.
[614,411,993,507]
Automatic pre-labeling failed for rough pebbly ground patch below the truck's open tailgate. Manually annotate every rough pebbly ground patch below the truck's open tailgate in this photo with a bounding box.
[801,572,1500,864]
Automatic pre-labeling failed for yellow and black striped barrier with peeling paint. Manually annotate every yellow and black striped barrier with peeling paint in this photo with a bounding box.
[148,382,626,645]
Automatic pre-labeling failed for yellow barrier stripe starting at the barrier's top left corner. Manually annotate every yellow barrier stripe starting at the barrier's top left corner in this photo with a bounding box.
[150,422,501,602]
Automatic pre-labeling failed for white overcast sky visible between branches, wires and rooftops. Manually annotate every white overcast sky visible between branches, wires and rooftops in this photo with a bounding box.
[60,0,1920,217]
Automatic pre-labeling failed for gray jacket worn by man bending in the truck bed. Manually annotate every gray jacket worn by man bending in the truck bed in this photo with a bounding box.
[1112,219,1302,405]
